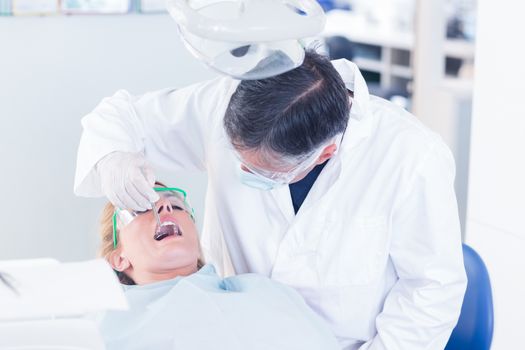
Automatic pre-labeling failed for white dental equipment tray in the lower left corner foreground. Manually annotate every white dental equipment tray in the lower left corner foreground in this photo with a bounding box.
[0,259,128,350]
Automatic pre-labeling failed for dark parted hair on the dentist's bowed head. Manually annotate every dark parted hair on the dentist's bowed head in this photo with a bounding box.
[224,51,350,156]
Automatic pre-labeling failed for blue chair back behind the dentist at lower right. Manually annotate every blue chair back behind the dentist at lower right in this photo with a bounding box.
[445,244,494,350]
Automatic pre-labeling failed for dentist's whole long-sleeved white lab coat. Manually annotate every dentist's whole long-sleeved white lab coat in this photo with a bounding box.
[75,60,466,350]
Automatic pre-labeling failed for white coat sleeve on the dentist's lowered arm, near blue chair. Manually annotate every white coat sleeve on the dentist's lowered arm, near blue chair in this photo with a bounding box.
[360,142,467,350]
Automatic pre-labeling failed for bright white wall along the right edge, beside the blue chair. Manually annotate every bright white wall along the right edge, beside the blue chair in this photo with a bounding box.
[466,0,525,350]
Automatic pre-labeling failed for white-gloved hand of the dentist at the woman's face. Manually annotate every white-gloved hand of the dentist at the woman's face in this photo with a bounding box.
[95,152,159,211]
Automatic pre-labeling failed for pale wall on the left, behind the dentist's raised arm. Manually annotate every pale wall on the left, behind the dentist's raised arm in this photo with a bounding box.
[0,15,213,261]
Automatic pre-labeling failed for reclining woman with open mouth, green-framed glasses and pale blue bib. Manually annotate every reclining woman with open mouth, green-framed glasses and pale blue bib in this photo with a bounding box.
[96,186,338,350]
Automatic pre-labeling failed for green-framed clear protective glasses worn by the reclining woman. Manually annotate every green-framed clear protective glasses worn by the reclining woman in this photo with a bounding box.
[113,187,195,249]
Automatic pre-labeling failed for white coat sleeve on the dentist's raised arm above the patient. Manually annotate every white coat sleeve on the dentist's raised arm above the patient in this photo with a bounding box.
[74,78,237,197]
